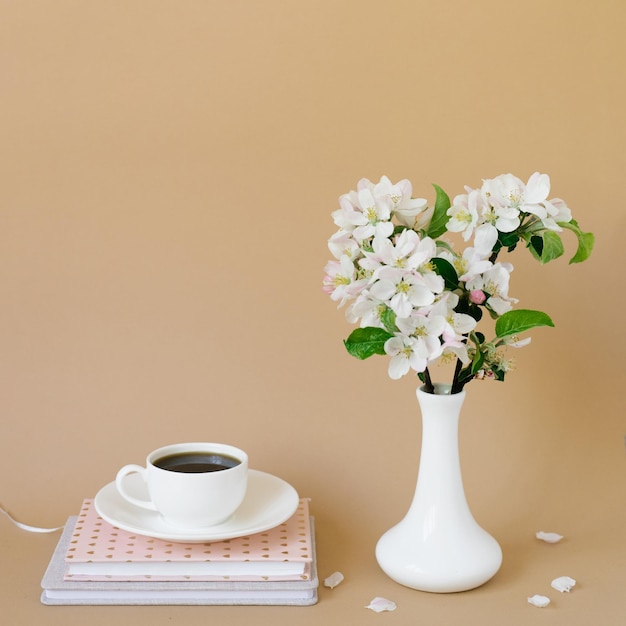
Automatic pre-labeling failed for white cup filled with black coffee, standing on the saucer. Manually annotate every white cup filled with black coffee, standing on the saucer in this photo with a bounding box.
[115,443,248,530]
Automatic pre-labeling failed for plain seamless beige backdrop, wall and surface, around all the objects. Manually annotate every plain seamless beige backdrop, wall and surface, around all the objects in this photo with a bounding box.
[0,0,626,626]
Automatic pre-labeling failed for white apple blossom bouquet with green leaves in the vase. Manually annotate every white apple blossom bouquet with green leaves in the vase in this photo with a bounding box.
[323,172,594,393]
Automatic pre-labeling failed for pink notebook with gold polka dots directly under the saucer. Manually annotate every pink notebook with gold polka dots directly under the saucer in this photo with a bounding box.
[64,498,313,581]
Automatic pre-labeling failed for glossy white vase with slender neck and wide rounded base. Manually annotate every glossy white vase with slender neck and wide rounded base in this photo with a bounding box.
[376,385,502,593]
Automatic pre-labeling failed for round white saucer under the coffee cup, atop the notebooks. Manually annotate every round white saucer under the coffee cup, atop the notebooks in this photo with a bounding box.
[94,470,300,543]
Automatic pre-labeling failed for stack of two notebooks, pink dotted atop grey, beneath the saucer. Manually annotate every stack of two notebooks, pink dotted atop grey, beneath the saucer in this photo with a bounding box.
[41,499,318,606]
